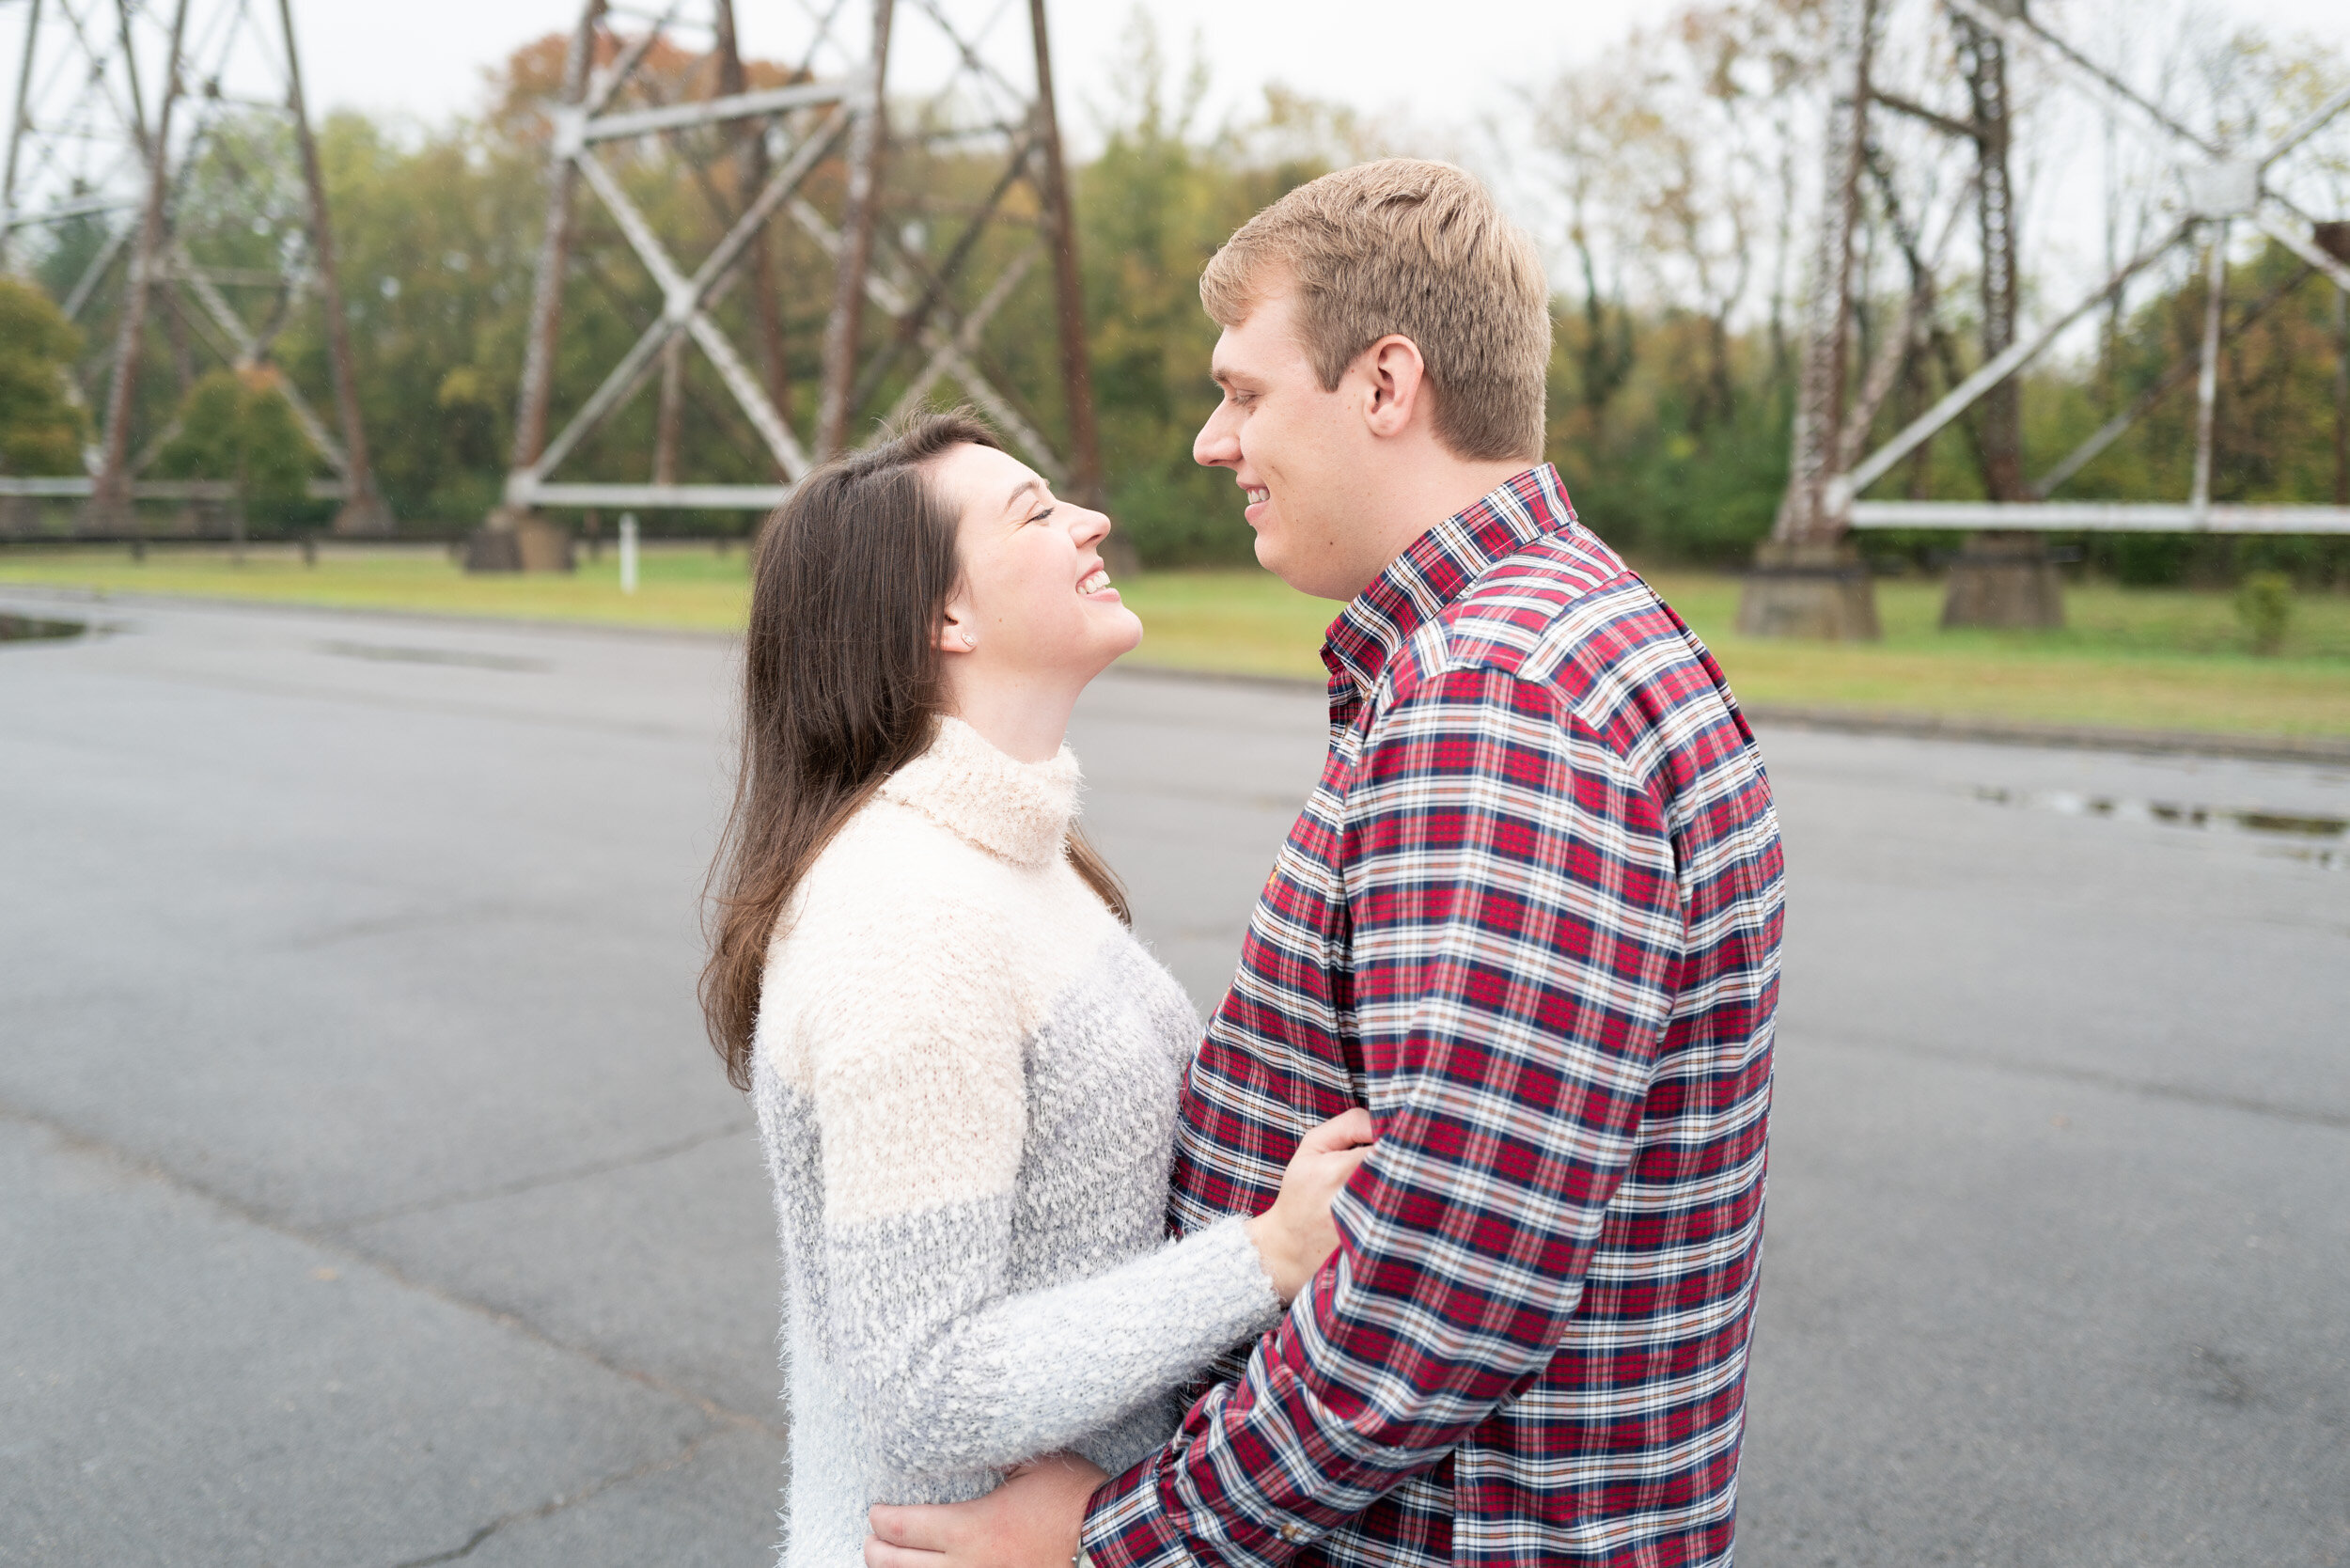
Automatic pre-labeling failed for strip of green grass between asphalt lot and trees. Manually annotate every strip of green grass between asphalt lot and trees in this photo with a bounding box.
[0,545,2350,738]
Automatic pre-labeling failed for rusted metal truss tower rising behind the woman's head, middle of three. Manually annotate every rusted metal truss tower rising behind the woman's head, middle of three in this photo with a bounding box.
[492,0,1100,517]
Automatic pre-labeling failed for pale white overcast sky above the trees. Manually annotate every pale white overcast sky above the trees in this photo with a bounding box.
[294,0,2350,134]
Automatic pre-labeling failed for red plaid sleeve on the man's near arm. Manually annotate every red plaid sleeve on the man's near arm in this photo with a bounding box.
[1086,670,1683,1568]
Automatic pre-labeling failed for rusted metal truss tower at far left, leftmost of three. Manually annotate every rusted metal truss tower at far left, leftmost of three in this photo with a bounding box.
[0,0,390,534]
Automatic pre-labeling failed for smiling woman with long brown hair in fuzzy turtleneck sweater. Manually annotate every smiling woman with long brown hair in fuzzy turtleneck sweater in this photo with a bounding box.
[703,414,1371,1568]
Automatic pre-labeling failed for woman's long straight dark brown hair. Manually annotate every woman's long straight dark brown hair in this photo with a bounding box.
[703,412,1133,1090]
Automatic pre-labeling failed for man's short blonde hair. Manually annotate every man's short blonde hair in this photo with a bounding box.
[1198,158,1551,463]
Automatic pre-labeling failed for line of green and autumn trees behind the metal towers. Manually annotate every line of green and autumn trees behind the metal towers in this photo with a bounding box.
[0,0,2350,586]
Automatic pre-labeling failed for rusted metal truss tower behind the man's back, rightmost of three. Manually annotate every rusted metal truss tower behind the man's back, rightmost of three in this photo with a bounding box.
[1775,0,2350,543]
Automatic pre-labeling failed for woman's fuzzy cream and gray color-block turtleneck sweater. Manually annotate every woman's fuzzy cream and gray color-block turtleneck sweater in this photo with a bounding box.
[752,719,1281,1568]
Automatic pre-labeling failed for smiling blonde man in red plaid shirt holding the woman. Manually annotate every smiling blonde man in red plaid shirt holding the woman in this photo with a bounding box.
[868,160,1784,1568]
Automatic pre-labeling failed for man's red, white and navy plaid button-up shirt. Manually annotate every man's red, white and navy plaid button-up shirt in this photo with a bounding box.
[1086,465,1781,1568]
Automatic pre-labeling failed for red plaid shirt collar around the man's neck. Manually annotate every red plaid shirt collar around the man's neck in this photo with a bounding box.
[1324,463,1574,700]
